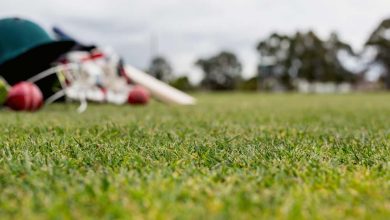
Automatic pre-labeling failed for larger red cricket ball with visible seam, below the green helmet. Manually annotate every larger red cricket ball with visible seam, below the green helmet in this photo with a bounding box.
[6,82,43,111]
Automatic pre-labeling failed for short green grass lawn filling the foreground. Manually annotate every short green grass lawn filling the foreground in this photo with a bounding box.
[0,94,390,219]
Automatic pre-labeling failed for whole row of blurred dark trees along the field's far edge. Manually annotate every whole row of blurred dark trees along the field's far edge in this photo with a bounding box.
[147,18,390,91]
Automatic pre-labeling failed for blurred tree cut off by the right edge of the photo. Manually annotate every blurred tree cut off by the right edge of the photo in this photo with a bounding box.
[366,18,390,89]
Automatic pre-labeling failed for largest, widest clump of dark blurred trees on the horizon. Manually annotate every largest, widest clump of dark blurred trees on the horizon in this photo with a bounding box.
[257,31,354,89]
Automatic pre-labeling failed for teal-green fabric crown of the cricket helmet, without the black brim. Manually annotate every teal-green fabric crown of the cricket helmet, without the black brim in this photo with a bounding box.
[0,18,53,65]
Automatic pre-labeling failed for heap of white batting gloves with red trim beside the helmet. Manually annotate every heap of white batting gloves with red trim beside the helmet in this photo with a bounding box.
[57,50,131,104]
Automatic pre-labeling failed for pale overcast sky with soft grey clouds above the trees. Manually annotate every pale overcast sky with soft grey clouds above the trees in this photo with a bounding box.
[0,0,390,82]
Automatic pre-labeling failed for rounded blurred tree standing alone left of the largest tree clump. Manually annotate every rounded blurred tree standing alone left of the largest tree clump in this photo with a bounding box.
[196,51,242,90]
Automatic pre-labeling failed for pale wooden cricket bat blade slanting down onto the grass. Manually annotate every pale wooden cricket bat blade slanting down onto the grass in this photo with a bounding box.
[124,65,196,105]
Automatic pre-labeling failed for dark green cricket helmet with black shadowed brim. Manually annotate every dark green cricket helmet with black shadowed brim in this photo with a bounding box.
[0,18,75,98]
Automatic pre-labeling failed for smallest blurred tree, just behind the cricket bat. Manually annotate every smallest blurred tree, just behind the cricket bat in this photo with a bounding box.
[147,56,173,82]
